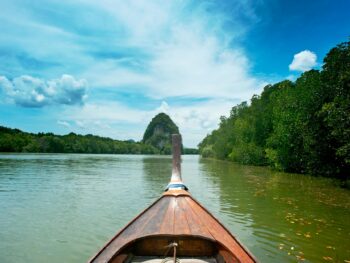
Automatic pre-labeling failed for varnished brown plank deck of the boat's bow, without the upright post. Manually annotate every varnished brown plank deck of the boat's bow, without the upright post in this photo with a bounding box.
[90,190,255,263]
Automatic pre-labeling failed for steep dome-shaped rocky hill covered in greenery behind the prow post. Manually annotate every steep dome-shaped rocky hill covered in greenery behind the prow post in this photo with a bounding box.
[142,113,179,154]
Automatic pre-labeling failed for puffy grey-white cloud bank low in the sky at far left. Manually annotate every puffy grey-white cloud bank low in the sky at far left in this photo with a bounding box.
[0,75,87,107]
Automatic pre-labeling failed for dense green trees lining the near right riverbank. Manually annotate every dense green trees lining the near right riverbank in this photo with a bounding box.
[198,42,350,182]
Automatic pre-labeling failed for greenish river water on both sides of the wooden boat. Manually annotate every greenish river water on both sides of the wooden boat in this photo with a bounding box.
[0,154,350,263]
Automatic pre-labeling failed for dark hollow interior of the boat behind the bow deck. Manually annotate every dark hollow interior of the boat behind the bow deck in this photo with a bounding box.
[110,236,239,263]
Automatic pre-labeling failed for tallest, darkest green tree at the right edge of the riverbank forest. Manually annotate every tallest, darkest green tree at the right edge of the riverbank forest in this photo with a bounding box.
[319,42,350,173]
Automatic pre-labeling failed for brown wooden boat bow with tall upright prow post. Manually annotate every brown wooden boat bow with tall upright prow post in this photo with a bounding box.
[89,135,256,263]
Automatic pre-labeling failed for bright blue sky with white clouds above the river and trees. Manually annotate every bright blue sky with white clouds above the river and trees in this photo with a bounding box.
[0,0,350,147]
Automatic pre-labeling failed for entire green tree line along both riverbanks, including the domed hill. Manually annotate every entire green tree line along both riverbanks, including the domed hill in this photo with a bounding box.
[0,41,350,184]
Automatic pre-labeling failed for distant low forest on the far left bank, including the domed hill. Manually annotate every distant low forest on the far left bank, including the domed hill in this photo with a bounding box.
[0,113,198,154]
